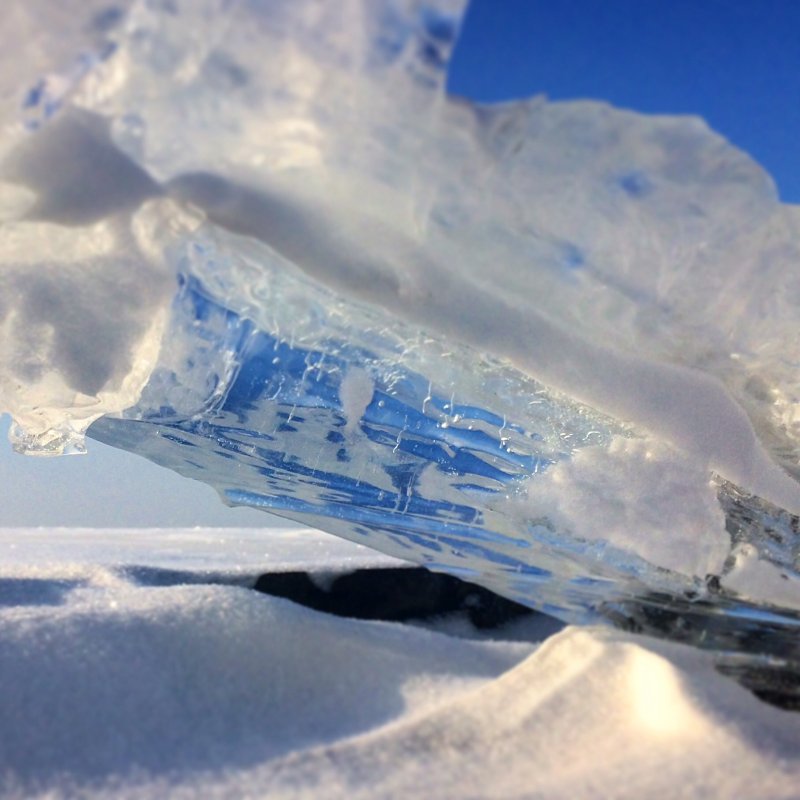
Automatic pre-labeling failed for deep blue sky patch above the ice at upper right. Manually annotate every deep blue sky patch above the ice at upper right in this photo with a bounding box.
[450,0,800,203]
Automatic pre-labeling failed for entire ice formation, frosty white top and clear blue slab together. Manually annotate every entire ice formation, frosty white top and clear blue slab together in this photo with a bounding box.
[0,0,800,662]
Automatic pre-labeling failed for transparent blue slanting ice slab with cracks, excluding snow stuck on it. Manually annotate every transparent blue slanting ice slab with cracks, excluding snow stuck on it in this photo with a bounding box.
[88,228,800,658]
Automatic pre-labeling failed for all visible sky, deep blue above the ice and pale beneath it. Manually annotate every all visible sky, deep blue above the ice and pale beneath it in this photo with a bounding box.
[0,0,800,526]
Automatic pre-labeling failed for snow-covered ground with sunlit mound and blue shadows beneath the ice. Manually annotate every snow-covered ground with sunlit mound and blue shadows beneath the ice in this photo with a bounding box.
[0,529,800,799]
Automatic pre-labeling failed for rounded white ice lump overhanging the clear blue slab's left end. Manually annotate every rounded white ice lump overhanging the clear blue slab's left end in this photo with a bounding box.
[0,203,174,454]
